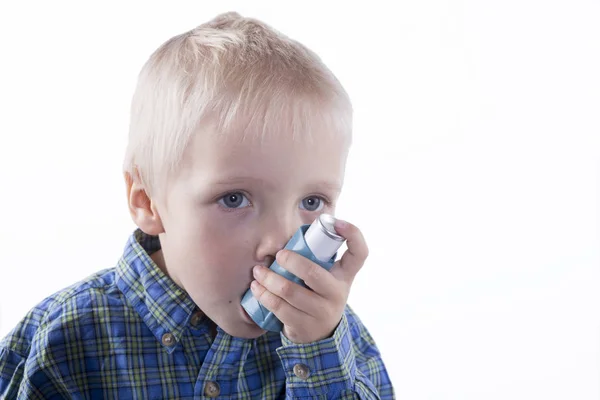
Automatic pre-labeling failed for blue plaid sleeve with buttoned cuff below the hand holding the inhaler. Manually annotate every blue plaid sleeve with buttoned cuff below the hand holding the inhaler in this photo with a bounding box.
[277,306,395,399]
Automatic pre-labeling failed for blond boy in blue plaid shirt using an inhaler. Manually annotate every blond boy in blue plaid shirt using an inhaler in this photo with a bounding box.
[0,13,394,399]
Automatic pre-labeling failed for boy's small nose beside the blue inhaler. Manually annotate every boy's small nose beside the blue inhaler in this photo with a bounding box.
[256,212,301,267]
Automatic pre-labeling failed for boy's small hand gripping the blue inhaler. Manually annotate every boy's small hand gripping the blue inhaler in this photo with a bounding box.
[251,221,369,344]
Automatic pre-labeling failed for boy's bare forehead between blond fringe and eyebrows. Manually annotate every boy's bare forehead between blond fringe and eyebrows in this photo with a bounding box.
[179,132,348,186]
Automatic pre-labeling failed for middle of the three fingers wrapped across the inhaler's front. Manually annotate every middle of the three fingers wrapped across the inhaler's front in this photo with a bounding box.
[253,265,324,316]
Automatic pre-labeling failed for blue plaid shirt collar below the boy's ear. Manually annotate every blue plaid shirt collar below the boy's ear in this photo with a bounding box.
[116,228,196,351]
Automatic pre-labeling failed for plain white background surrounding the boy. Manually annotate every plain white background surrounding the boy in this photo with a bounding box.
[0,0,600,400]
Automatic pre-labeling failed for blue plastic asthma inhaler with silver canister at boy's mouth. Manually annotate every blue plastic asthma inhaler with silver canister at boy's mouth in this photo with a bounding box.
[242,214,345,332]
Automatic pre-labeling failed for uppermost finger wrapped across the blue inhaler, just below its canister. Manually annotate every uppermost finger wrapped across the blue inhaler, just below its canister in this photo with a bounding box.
[276,250,340,299]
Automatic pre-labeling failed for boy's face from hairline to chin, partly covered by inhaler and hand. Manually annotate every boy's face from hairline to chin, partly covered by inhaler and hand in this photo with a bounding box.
[150,129,347,338]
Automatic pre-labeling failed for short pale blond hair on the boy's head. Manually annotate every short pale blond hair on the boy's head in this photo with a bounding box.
[124,12,352,191]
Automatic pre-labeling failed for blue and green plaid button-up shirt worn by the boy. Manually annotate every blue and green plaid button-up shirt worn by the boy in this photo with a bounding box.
[0,230,394,399]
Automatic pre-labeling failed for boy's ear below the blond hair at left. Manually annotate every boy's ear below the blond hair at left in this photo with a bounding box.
[125,171,165,236]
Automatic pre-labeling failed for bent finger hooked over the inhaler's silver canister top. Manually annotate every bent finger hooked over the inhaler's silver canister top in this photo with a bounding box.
[331,220,369,283]
